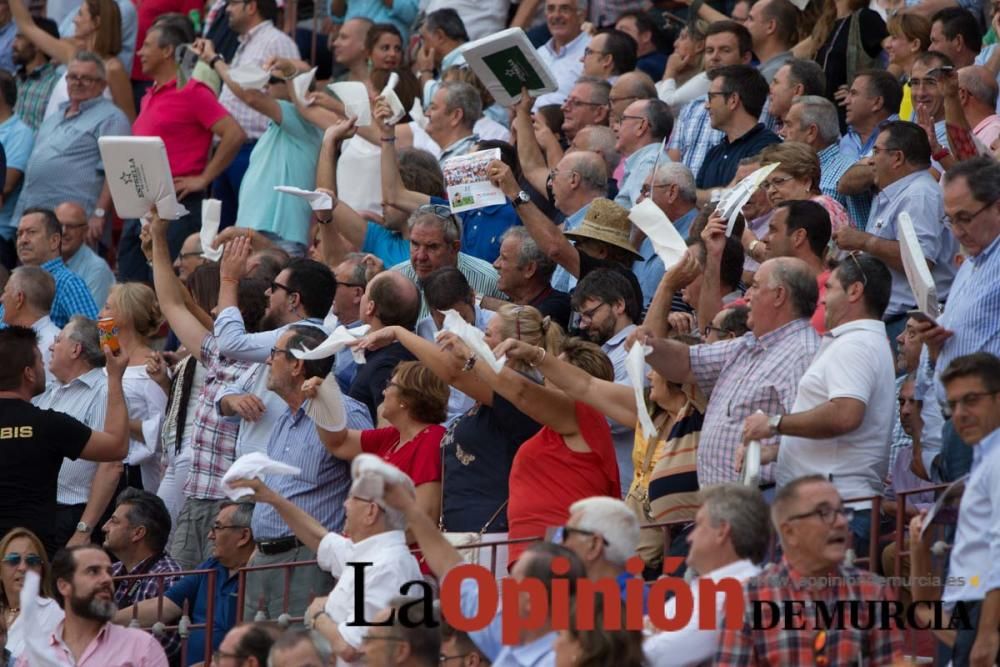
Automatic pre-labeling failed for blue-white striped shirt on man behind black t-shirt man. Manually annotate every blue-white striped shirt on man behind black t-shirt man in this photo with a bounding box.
[31,368,108,505]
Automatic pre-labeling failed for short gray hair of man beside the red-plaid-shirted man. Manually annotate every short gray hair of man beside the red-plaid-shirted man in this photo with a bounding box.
[698,484,771,563]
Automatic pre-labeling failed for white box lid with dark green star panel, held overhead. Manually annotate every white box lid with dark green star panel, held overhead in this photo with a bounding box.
[461,28,559,107]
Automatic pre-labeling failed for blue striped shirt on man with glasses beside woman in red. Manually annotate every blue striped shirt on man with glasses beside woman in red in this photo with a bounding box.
[250,399,371,541]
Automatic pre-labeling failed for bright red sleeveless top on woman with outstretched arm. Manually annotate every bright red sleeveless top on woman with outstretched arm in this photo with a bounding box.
[507,402,621,565]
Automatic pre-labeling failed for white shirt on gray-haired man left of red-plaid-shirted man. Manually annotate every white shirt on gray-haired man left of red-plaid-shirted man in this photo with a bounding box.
[642,559,760,667]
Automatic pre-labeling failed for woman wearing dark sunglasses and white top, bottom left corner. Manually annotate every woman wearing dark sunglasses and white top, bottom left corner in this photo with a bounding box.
[0,528,63,658]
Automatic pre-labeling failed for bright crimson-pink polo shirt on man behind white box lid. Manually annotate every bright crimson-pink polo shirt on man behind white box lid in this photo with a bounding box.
[132,79,229,178]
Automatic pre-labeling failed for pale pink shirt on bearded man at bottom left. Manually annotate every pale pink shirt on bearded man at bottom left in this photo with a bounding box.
[15,623,168,667]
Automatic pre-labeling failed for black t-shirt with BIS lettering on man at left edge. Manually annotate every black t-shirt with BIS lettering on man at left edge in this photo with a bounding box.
[0,398,91,554]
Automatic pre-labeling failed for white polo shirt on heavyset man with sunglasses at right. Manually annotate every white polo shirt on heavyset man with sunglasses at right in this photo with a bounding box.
[776,319,895,509]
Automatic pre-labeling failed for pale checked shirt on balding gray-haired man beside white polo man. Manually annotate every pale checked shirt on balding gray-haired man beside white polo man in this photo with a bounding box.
[689,319,820,486]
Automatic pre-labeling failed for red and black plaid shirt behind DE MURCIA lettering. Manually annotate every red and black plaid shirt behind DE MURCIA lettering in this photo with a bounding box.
[715,560,903,667]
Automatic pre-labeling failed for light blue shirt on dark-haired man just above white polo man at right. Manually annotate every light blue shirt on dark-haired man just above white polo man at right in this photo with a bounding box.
[866,169,958,319]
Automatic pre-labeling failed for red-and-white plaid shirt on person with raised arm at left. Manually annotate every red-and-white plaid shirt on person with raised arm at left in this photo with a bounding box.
[184,334,254,500]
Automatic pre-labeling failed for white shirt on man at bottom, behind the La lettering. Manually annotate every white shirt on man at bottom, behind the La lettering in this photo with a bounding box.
[316,530,423,665]
